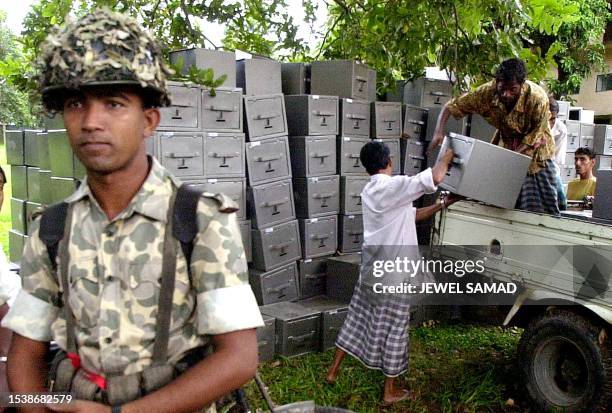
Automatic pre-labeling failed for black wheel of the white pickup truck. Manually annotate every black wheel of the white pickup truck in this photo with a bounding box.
[518,309,612,413]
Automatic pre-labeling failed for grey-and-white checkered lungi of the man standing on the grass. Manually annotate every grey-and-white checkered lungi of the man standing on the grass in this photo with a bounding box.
[336,284,410,377]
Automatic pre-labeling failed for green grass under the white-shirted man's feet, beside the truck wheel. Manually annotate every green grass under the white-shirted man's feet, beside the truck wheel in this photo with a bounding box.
[247,325,522,413]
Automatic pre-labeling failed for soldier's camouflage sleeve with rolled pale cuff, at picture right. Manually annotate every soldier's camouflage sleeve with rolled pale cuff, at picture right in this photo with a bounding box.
[191,198,263,334]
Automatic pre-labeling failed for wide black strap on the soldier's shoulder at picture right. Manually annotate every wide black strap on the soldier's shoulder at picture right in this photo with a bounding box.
[172,185,204,268]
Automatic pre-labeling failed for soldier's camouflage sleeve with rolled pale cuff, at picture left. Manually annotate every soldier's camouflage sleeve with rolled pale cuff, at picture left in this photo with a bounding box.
[2,219,59,341]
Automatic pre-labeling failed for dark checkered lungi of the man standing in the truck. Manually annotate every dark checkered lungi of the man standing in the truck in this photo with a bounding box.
[516,160,559,215]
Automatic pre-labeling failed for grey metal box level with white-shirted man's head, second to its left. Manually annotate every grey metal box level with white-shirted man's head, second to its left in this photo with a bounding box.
[289,135,336,177]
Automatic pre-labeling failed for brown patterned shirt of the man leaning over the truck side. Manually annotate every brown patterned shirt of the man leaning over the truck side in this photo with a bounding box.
[447,80,555,174]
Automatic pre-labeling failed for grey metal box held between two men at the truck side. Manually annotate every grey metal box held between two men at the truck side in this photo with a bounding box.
[440,133,531,208]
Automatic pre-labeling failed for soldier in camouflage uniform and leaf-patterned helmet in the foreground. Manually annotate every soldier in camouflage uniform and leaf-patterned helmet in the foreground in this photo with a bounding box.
[3,10,263,413]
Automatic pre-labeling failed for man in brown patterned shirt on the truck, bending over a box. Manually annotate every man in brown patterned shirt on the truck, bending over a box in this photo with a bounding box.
[431,59,559,215]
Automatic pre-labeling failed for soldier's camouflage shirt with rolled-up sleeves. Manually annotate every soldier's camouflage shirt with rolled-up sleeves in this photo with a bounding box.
[3,159,263,375]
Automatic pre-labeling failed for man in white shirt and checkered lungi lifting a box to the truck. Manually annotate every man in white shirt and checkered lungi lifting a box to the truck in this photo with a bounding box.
[327,141,460,405]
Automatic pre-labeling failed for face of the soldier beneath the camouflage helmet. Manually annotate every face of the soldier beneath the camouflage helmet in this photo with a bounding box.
[64,89,159,174]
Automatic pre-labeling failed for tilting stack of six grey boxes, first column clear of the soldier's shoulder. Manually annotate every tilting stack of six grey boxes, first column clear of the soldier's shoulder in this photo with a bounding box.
[236,59,302,312]
